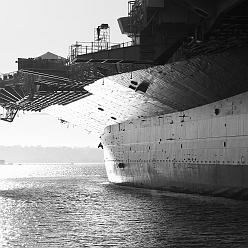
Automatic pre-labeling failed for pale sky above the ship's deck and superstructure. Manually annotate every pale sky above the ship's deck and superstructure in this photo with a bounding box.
[0,0,128,73]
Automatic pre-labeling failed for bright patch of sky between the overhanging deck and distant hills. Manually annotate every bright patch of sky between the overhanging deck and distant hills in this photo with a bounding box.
[0,112,99,147]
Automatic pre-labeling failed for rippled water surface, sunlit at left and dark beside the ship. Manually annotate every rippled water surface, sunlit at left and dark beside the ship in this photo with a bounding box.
[0,164,248,248]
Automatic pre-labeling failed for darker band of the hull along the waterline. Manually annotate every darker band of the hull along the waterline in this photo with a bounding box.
[107,164,248,200]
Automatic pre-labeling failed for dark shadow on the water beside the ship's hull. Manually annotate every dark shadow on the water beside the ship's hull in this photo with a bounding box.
[106,184,248,247]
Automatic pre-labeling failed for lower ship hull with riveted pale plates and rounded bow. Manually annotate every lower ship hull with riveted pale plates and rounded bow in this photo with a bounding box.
[102,92,248,200]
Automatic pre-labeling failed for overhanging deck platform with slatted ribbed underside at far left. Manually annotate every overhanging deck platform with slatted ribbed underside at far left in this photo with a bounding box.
[0,70,90,122]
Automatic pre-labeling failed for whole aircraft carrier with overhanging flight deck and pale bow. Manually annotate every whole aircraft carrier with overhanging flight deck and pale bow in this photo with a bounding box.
[0,0,248,200]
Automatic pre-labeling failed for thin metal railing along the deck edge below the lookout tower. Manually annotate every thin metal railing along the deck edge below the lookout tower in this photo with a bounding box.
[68,41,136,62]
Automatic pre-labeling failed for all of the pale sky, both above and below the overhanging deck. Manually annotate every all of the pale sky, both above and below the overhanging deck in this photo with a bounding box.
[0,0,131,146]
